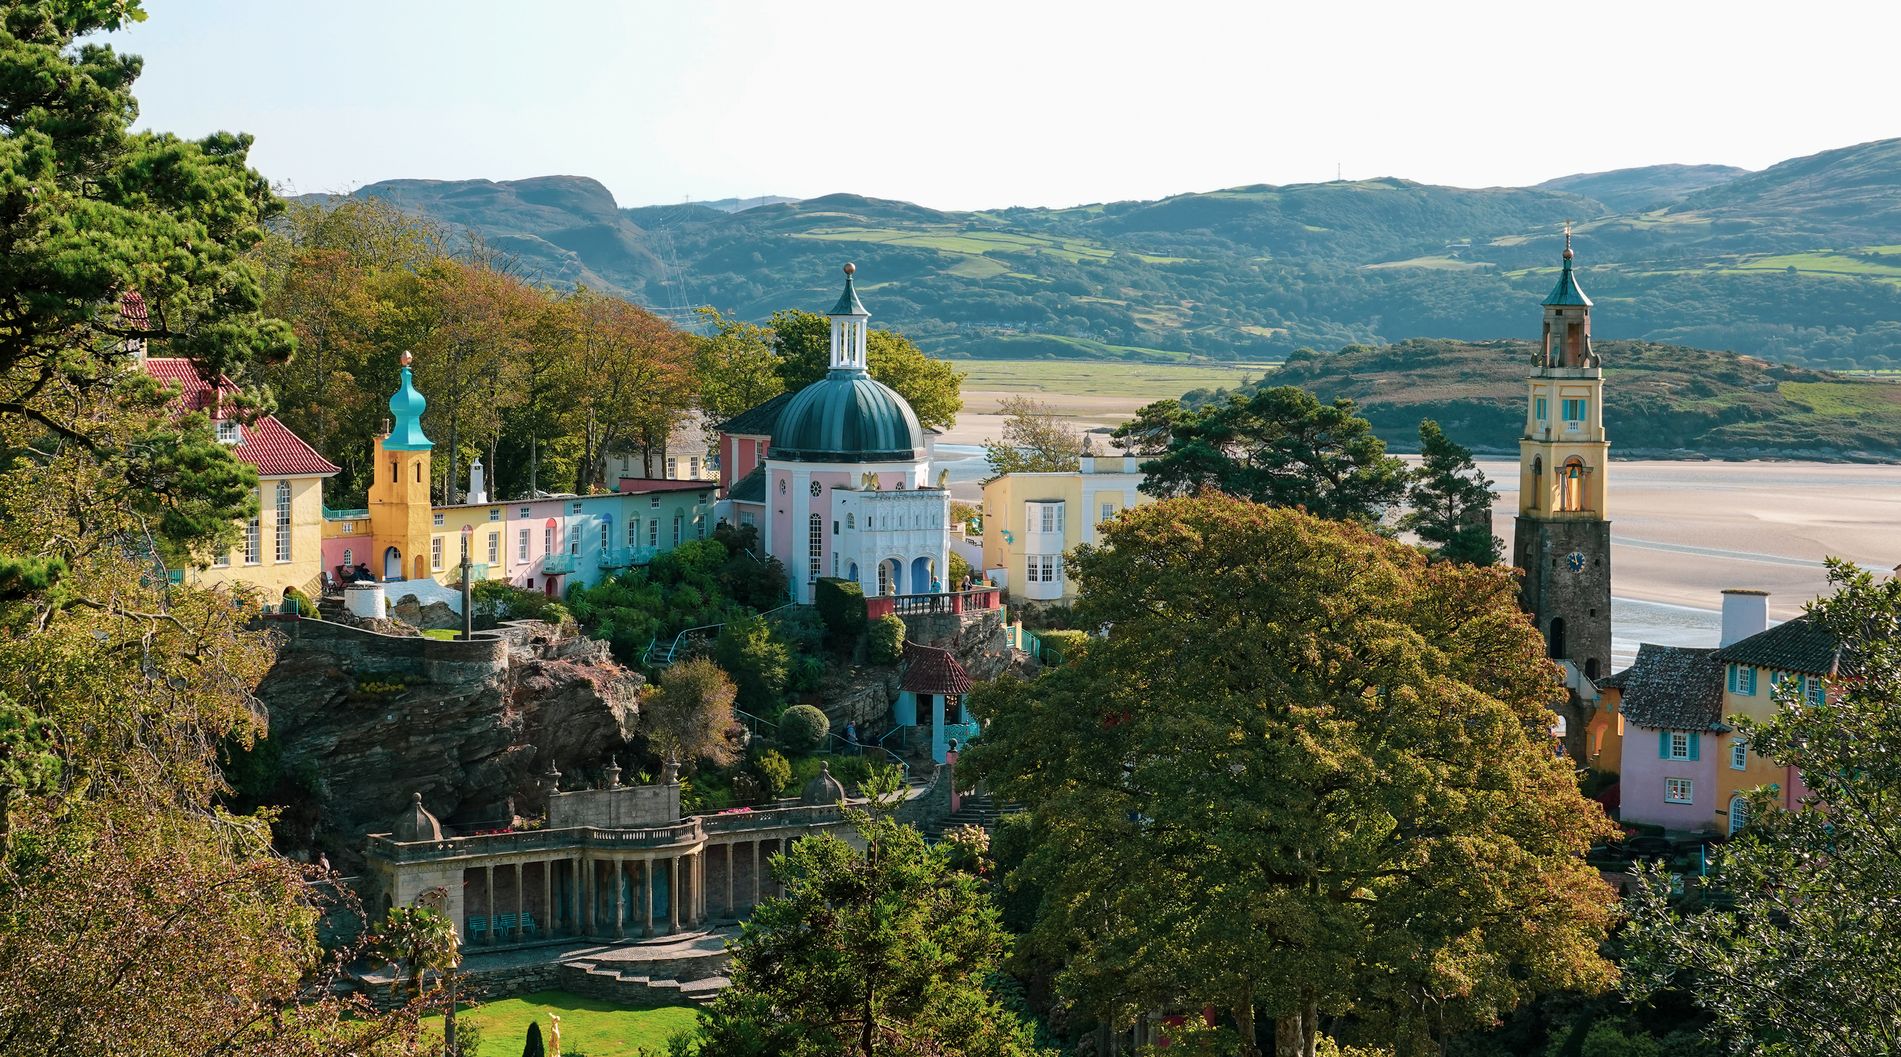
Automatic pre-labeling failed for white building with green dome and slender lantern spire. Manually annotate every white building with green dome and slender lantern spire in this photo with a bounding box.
[720,264,951,603]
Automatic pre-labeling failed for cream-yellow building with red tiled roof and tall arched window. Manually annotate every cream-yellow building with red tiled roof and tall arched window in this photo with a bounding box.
[144,357,338,601]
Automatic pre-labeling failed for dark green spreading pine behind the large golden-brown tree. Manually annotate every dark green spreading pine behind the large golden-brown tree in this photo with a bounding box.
[1131,386,1407,523]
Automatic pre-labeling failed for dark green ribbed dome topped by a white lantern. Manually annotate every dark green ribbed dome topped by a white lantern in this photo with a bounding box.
[770,369,924,462]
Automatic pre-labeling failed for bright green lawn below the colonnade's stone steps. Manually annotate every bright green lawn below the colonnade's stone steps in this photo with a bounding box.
[430,990,700,1057]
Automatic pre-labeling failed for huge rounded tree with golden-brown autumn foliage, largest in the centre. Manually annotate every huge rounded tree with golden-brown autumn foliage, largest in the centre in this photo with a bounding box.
[960,494,1612,1055]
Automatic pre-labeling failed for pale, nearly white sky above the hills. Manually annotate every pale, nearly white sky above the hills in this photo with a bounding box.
[114,0,1901,209]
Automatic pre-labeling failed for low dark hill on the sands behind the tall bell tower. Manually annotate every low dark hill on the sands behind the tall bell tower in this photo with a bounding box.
[1247,340,1901,460]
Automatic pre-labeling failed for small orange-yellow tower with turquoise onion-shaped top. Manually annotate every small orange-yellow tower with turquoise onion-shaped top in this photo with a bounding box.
[369,352,435,580]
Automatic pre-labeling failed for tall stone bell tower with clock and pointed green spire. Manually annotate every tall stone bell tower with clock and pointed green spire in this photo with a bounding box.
[1511,224,1610,688]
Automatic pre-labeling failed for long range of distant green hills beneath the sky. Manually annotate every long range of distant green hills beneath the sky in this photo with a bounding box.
[334,141,1901,369]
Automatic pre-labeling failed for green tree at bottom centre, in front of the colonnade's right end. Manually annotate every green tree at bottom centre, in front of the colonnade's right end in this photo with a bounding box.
[700,812,1036,1057]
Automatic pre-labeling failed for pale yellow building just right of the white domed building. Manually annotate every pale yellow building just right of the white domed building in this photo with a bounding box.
[983,454,1152,601]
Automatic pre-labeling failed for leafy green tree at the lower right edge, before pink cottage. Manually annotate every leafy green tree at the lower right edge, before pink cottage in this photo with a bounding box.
[1625,559,1901,1057]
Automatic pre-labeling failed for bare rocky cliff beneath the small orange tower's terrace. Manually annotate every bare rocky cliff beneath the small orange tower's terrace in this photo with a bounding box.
[259,620,644,869]
